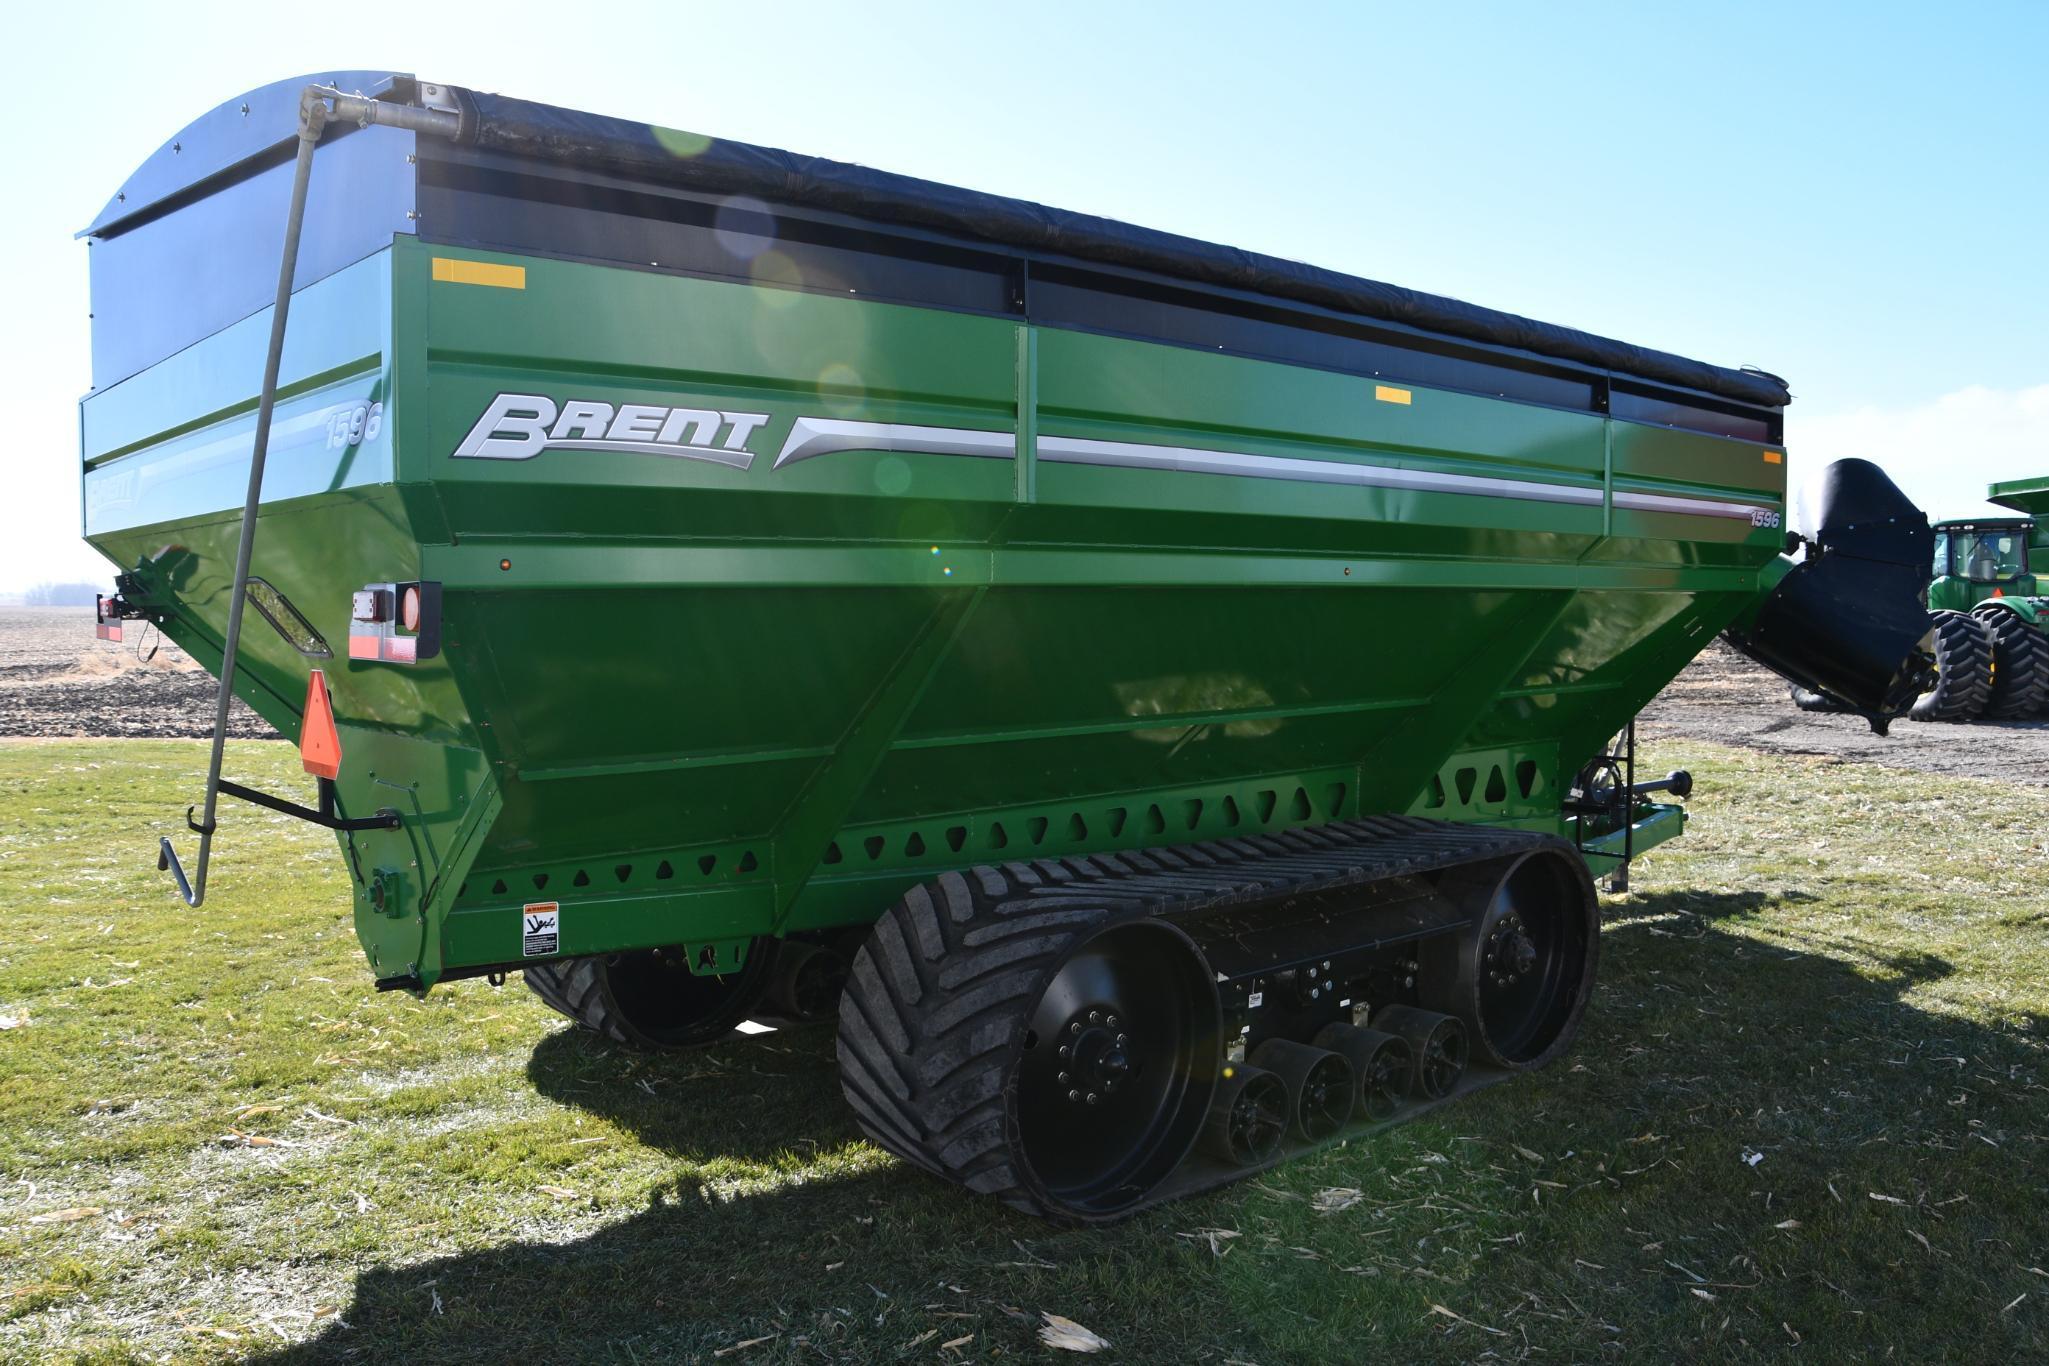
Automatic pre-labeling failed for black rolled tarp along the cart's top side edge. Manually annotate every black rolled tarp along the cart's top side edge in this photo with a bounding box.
[459,90,1791,408]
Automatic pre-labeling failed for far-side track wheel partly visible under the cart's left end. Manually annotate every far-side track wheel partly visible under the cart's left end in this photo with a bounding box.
[525,940,777,1051]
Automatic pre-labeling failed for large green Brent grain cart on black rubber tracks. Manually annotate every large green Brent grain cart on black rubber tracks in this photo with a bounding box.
[82,72,1928,1221]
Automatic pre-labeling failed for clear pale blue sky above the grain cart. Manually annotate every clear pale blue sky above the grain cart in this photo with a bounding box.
[0,0,2049,592]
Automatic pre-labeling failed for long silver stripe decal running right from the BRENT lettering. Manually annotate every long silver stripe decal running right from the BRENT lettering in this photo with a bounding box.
[770,418,1774,520]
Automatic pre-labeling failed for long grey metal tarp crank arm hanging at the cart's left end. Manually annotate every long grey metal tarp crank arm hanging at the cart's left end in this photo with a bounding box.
[156,86,463,905]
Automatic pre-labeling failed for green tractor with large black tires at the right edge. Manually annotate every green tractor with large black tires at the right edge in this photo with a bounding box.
[1912,477,2049,721]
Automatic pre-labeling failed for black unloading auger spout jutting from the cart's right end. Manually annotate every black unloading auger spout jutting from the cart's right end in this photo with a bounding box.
[1725,459,1934,735]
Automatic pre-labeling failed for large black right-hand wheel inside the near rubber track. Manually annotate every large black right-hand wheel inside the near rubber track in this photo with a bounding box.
[1422,850,1600,1071]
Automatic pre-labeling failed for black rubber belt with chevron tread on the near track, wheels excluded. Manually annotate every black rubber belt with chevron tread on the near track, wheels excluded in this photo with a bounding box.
[838,817,1563,1221]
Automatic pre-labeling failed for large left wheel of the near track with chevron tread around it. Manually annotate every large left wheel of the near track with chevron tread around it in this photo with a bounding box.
[840,864,1223,1223]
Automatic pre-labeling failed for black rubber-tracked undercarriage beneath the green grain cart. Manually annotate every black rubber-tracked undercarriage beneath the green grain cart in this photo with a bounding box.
[529,817,1598,1223]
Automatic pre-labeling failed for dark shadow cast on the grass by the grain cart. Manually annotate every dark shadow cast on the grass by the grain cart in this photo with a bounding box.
[252,891,2049,1362]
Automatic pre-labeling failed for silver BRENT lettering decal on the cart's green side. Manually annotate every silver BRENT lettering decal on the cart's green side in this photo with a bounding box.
[455,393,768,469]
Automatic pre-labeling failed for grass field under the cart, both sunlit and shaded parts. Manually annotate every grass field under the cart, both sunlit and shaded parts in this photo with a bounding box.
[0,741,2049,1366]
